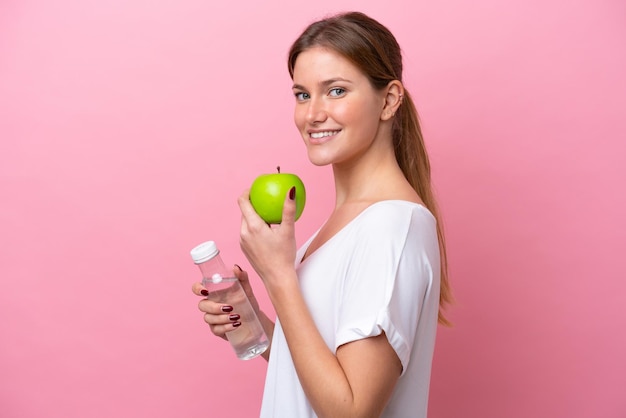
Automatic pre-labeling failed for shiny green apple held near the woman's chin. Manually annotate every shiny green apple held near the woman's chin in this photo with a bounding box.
[250,167,306,224]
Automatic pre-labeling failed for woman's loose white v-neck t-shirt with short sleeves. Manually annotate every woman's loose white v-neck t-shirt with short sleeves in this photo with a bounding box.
[261,200,440,418]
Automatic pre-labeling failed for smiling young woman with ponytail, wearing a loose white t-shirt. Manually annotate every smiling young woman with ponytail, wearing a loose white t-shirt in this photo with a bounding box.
[193,12,450,418]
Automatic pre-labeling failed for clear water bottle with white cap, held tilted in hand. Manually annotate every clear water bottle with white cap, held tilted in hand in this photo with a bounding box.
[191,241,269,360]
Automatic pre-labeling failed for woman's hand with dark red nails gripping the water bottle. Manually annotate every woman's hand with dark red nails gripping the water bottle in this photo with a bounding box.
[191,266,259,339]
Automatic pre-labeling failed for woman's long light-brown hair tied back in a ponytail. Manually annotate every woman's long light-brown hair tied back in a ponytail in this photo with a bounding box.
[288,12,452,325]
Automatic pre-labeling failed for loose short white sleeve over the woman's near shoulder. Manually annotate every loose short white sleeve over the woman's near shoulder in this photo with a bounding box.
[335,201,439,370]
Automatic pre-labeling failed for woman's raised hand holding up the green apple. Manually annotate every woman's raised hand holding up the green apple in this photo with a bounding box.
[238,187,296,287]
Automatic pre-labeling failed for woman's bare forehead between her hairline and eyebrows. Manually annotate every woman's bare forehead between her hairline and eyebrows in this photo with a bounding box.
[293,47,366,84]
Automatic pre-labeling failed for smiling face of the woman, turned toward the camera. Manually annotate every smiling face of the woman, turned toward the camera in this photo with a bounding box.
[293,47,385,165]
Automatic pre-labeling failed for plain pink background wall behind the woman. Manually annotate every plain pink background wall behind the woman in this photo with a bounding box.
[0,0,626,418]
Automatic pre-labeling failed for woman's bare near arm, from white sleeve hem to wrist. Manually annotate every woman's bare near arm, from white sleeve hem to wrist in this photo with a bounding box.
[270,274,402,417]
